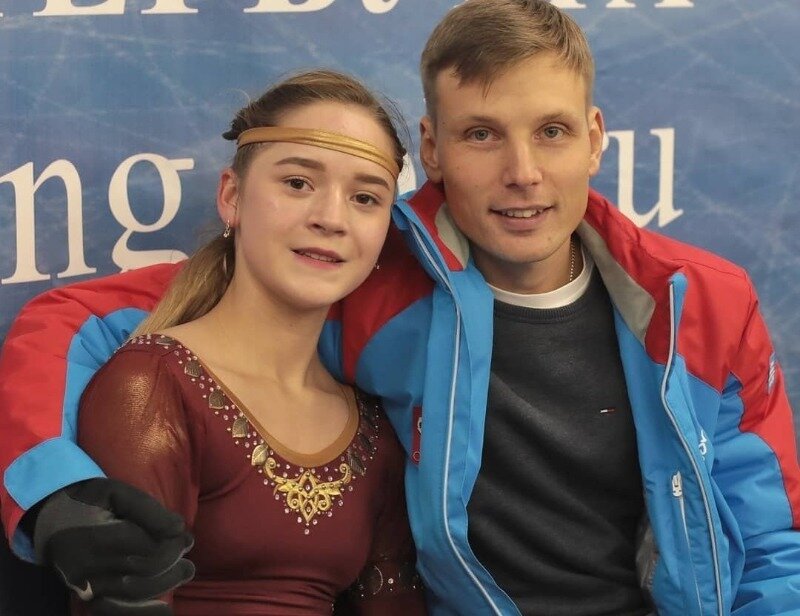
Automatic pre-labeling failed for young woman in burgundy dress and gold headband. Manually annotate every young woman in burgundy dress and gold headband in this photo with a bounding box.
[73,71,425,616]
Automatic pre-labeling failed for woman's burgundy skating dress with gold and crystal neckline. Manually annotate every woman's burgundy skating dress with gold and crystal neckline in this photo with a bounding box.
[78,335,425,616]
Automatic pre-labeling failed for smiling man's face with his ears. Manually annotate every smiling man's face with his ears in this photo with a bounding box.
[420,54,603,293]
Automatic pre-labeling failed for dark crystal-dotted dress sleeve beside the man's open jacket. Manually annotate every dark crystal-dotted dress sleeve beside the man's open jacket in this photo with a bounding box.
[346,436,427,616]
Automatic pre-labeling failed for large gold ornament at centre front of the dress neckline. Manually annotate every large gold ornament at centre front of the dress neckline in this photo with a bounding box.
[260,458,353,526]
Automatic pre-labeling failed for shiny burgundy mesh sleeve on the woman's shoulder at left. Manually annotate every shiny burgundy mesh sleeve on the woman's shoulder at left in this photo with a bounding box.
[78,348,200,601]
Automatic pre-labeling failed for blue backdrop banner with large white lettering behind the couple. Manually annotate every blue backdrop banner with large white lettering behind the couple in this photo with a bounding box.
[0,0,800,434]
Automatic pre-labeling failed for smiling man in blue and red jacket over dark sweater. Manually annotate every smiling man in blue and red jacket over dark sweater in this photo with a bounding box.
[0,0,800,616]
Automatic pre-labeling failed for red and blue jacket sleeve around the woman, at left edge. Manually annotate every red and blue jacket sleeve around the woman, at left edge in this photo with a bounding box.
[0,264,180,560]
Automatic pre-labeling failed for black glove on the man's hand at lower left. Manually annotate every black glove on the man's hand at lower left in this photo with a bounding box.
[33,478,194,616]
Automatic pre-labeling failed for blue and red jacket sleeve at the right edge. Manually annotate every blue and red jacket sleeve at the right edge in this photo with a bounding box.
[714,286,800,616]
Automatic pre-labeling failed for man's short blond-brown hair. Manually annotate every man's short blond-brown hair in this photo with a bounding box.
[420,0,594,119]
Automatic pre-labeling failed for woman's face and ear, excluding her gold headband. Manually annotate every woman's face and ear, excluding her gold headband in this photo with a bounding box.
[219,102,395,310]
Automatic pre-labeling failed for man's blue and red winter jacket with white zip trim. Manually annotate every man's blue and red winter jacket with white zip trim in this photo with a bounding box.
[0,184,800,616]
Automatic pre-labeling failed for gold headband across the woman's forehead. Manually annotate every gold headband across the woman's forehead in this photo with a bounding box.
[236,126,400,180]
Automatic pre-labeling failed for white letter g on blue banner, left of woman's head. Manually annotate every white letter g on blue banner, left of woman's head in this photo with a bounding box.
[108,153,194,271]
